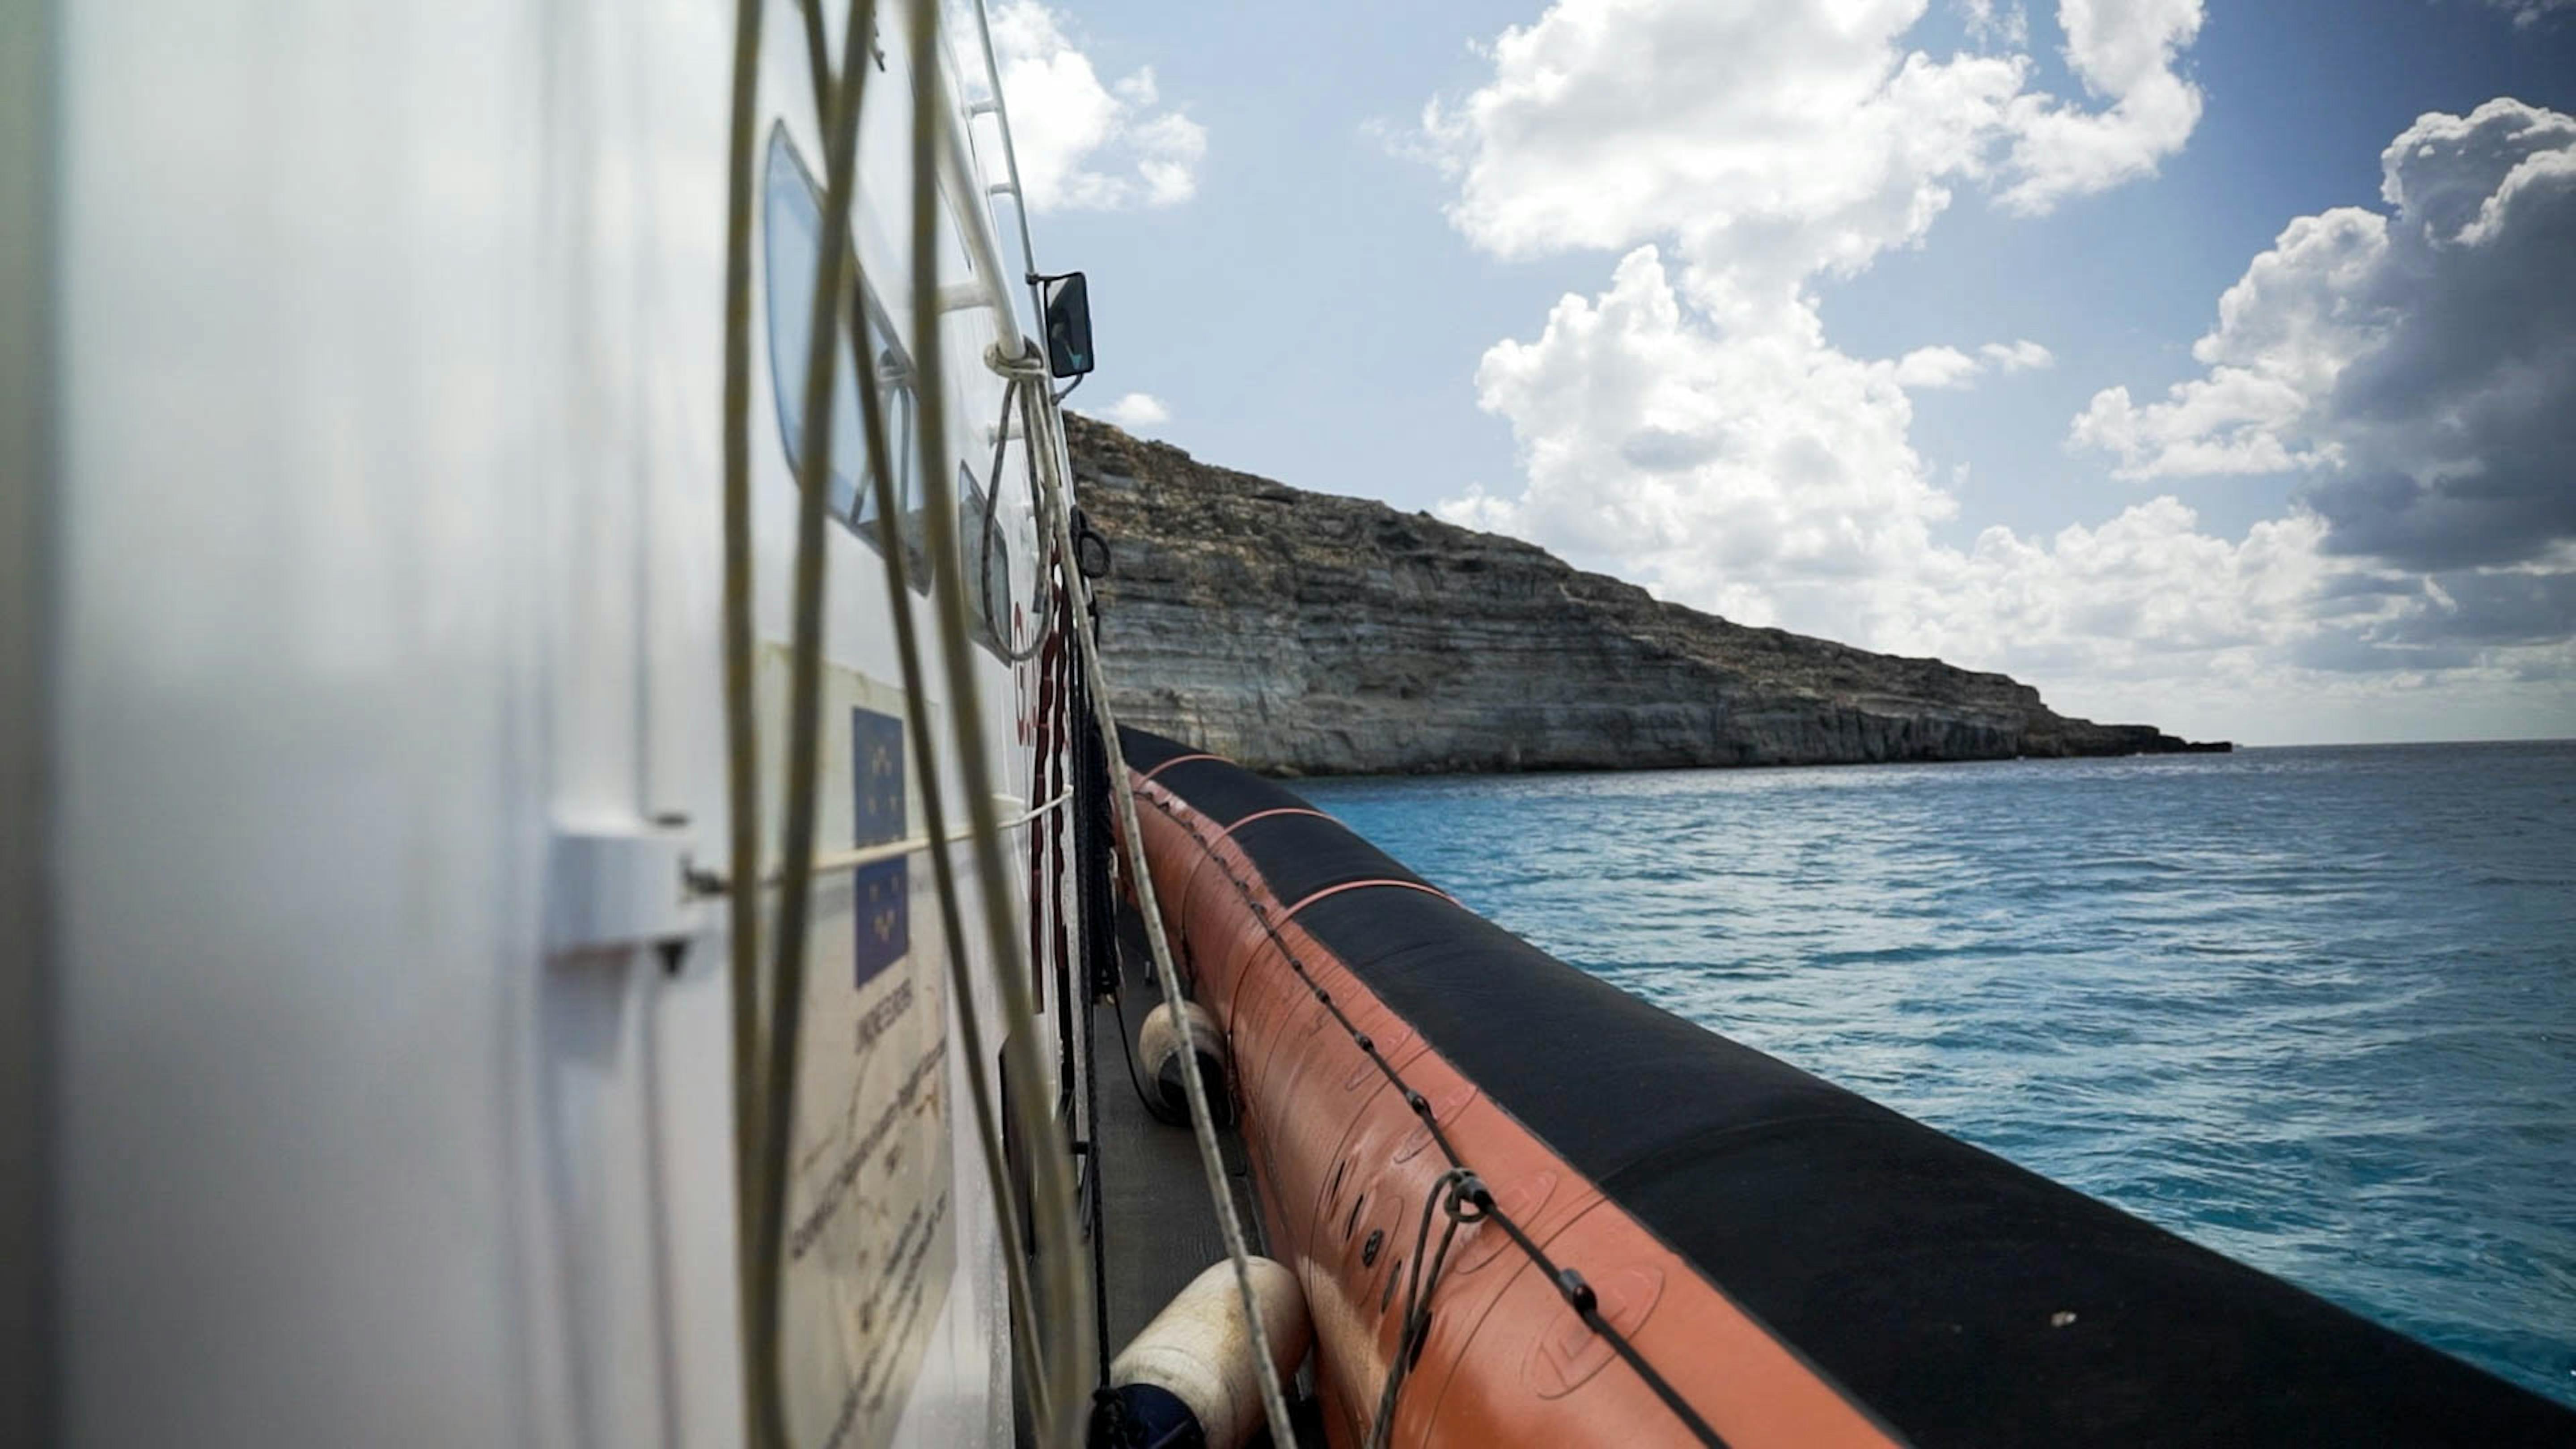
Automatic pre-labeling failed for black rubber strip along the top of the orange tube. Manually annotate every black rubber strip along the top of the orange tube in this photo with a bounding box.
[1128,732,2576,1446]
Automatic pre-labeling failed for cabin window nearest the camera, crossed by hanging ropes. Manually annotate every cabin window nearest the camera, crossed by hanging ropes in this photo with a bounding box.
[763,126,930,580]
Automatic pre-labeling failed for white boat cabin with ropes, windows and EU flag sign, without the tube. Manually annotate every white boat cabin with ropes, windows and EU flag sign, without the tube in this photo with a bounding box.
[0,0,1118,1446]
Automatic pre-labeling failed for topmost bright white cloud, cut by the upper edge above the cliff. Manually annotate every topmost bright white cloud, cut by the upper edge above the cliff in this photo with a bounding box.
[1424,0,2200,307]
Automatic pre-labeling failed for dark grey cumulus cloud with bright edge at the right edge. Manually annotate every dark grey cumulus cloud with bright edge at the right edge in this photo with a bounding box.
[2071,101,2576,570]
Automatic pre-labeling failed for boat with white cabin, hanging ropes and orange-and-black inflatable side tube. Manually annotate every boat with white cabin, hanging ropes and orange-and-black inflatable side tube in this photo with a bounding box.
[0,0,2576,1449]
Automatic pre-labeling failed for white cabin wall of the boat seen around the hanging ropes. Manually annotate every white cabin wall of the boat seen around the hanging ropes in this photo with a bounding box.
[51,0,1025,1446]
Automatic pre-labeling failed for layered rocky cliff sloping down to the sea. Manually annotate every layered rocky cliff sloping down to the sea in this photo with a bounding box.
[1067,415,2223,774]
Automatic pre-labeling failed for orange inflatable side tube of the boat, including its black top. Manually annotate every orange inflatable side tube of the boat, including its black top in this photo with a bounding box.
[1126,730,2576,1449]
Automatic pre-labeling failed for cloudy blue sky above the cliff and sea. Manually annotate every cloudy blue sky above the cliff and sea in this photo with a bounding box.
[974,0,2576,742]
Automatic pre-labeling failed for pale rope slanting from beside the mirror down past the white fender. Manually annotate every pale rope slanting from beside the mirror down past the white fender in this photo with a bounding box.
[987,340,1296,1444]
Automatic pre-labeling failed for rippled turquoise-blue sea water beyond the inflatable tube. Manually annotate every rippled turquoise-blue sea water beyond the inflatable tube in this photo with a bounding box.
[1298,742,2576,1402]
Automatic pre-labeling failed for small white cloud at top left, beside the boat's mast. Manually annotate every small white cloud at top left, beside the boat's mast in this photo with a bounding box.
[992,0,1208,212]
